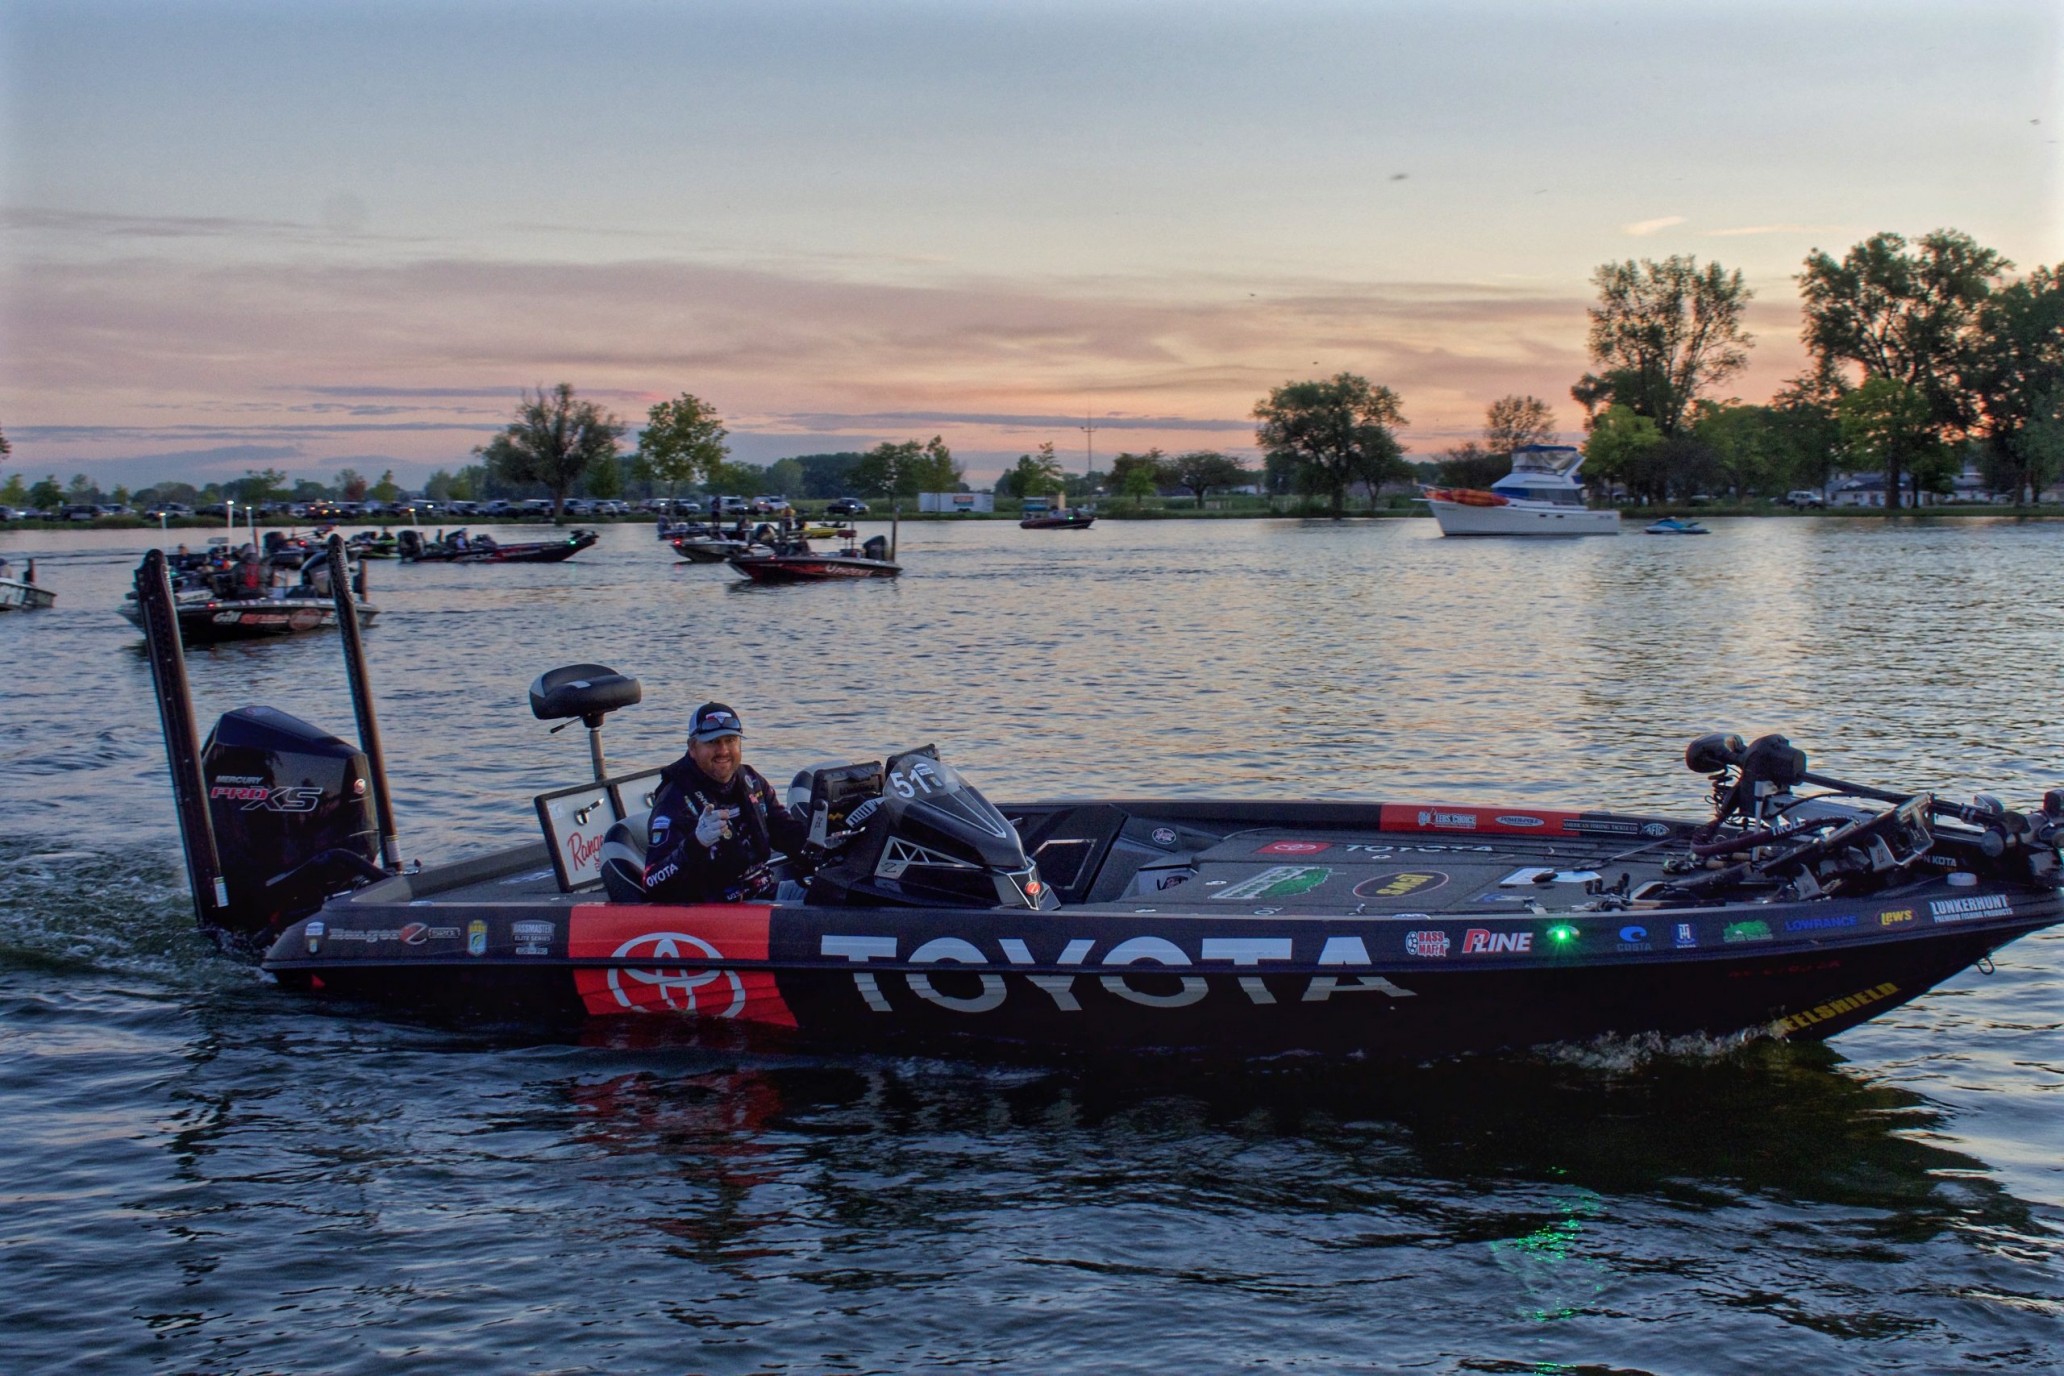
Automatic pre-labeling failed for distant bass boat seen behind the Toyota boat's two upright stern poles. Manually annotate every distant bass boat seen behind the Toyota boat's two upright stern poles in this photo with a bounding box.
[116,545,380,646]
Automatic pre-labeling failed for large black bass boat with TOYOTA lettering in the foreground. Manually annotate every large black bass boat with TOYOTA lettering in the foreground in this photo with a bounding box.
[138,551,2064,1058]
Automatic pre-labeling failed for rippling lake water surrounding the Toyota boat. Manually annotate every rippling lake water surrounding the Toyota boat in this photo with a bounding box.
[0,520,2064,1374]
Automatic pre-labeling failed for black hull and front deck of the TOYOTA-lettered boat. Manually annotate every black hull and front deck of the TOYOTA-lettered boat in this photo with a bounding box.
[264,800,2064,1058]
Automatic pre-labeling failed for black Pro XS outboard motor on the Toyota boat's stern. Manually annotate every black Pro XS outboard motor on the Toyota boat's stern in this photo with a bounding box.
[200,708,384,937]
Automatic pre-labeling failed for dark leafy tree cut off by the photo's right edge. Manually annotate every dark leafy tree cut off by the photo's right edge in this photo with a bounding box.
[1965,264,2064,501]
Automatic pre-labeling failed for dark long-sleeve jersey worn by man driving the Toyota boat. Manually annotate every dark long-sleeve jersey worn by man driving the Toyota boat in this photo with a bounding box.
[644,755,807,904]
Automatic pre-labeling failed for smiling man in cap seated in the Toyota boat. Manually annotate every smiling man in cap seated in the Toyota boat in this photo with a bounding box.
[644,701,807,904]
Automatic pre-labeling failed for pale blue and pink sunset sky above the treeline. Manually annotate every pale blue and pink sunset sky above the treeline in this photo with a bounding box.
[0,0,2064,489]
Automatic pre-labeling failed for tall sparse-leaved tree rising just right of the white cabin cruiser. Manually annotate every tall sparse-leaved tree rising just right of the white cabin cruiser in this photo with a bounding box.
[1571,256,1754,439]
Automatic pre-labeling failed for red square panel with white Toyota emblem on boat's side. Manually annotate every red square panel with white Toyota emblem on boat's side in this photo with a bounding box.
[566,904,795,1027]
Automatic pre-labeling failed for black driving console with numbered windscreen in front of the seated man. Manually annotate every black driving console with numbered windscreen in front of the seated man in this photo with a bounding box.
[809,745,1061,910]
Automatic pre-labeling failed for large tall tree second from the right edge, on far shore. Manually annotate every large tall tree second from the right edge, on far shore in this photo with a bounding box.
[1798,229,2012,514]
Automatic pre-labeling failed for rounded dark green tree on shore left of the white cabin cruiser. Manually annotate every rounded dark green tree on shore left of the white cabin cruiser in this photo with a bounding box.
[1255,373,1412,520]
